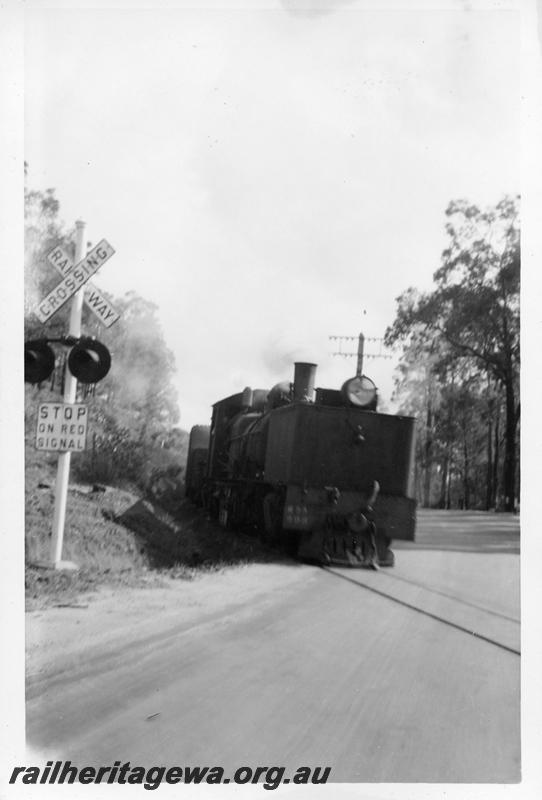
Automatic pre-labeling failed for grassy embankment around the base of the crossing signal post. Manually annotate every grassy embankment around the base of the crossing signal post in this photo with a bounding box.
[25,451,277,608]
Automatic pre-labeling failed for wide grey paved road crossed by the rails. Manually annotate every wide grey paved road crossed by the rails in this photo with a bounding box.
[27,512,520,783]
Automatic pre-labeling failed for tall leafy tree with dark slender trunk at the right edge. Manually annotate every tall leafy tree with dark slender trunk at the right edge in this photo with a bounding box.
[385,197,520,511]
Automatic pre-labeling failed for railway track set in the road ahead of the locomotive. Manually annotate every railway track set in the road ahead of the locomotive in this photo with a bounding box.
[322,566,521,656]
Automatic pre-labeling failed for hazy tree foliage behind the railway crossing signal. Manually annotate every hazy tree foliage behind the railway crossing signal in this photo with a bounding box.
[25,180,188,491]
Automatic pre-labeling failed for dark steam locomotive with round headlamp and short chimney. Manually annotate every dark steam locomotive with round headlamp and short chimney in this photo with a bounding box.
[185,362,416,568]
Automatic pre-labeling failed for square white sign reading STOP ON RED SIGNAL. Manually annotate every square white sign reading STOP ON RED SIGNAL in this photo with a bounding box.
[36,403,88,453]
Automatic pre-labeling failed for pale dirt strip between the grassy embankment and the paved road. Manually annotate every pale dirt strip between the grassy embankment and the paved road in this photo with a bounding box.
[26,562,318,685]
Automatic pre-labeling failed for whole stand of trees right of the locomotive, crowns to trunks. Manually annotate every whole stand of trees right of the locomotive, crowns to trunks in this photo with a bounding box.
[386,197,520,510]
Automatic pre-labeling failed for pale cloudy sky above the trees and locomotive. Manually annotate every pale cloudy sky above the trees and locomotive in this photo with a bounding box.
[24,0,520,430]
